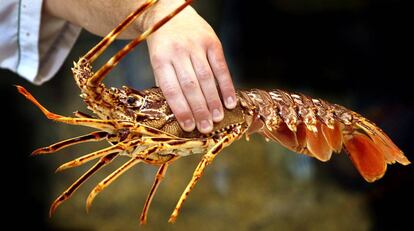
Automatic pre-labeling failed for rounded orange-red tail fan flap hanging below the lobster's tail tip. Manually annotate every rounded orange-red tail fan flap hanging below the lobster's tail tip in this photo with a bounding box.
[344,132,387,182]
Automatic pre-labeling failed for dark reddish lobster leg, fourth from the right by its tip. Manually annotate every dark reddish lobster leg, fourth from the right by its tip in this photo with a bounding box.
[49,153,118,217]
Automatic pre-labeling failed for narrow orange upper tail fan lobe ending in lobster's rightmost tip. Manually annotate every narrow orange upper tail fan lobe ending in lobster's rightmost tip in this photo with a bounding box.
[357,119,410,165]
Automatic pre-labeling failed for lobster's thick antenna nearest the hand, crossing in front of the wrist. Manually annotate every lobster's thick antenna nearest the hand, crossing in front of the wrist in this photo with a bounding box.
[87,0,192,86]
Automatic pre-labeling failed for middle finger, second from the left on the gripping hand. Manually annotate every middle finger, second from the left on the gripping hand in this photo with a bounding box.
[173,55,213,133]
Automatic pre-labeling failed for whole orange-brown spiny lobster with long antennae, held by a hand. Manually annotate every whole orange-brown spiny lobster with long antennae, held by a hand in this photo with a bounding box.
[17,0,410,224]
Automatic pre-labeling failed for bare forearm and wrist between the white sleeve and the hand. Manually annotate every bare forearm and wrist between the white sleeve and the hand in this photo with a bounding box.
[43,0,192,39]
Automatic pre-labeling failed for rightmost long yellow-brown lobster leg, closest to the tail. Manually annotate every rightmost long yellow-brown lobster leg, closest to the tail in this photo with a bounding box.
[168,132,243,223]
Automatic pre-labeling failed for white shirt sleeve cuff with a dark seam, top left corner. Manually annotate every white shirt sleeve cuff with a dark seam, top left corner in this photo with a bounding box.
[0,0,81,84]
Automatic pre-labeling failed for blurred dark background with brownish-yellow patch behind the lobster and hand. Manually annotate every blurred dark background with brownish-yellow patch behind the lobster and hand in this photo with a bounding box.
[0,0,414,230]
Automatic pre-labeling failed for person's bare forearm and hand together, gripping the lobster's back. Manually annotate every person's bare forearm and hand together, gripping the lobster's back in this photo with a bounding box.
[43,0,237,133]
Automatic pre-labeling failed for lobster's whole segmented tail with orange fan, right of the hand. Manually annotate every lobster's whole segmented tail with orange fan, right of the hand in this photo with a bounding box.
[239,89,410,182]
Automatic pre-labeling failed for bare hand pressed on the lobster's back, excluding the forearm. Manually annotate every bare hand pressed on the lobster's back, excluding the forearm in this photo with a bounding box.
[145,2,237,133]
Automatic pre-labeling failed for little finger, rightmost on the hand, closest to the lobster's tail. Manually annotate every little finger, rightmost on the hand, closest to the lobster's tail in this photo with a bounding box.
[207,43,237,109]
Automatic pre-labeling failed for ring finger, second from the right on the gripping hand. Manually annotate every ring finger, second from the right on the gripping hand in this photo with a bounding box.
[191,54,224,122]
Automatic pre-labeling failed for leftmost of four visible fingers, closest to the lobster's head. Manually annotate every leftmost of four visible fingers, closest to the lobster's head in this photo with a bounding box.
[154,63,195,132]
